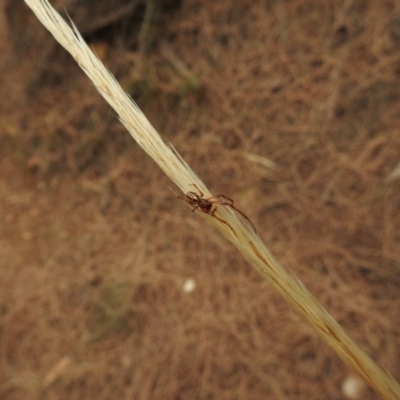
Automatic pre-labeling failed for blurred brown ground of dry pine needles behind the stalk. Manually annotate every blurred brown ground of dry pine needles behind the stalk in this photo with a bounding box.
[0,0,400,399]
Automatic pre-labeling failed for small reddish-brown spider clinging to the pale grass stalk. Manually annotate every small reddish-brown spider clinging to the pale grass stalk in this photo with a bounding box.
[177,183,257,235]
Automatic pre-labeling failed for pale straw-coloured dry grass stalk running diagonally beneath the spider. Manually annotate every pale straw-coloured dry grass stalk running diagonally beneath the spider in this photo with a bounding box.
[25,0,400,400]
